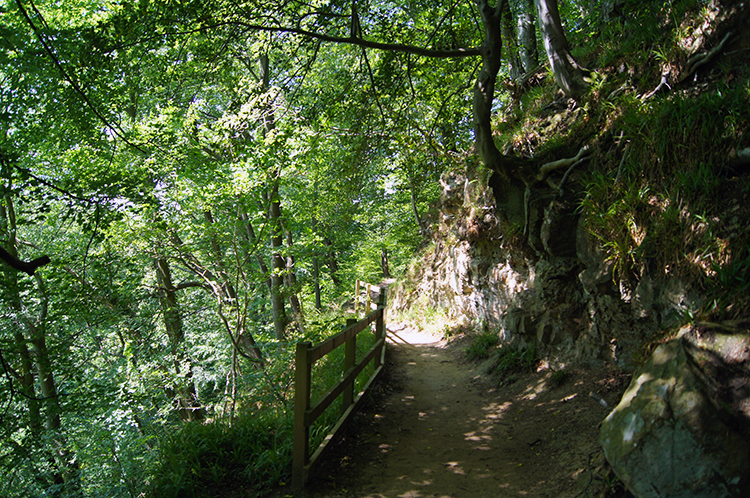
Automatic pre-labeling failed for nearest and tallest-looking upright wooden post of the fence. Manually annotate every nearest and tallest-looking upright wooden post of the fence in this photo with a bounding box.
[292,342,312,489]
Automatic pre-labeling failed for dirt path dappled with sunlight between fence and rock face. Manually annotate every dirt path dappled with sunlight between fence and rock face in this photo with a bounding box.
[279,327,630,498]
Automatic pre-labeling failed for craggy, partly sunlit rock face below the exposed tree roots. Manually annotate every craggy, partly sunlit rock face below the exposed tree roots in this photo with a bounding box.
[389,160,692,366]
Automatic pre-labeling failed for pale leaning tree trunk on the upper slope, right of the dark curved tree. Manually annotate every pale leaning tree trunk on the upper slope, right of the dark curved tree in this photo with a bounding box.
[534,0,588,99]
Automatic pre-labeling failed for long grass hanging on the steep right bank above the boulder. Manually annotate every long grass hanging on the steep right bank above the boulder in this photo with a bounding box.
[580,79,750,309]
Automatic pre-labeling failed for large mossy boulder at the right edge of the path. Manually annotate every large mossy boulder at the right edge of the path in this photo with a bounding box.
[600,325,750,498]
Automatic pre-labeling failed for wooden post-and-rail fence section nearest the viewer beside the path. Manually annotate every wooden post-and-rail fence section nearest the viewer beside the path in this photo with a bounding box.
[292,289,386,488]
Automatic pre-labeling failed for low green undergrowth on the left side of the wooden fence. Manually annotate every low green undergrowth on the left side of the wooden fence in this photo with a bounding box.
[149,318,382,498]
